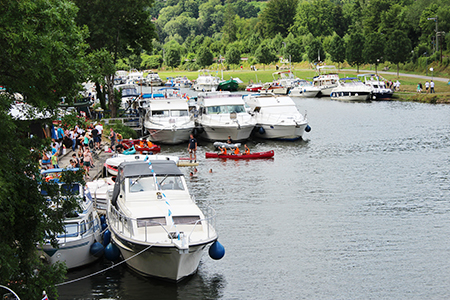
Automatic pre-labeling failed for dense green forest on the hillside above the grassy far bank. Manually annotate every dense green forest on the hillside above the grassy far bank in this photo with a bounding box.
[128,0,450,70]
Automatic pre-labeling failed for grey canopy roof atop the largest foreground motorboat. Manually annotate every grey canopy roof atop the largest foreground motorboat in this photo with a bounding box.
[118,160,183,178]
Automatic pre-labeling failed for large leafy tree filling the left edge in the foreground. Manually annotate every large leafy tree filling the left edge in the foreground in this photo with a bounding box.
[0,0,87,299]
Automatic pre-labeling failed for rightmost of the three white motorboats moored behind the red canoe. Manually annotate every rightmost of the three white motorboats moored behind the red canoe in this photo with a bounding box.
[245,94,309,140]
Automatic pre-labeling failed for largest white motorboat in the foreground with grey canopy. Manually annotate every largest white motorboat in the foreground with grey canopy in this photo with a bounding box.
[107,161,224,281]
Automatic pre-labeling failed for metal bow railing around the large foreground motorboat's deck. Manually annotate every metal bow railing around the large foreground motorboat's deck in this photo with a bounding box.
[108,206,216,242]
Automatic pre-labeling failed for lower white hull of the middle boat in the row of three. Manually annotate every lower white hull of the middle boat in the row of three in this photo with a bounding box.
[200,124,255,142]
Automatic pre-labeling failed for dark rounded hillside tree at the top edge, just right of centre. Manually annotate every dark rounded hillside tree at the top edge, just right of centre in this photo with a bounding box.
[259,0,298,38]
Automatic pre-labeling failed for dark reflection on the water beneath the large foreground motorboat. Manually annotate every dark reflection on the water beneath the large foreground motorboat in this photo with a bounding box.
[58,254,226,299]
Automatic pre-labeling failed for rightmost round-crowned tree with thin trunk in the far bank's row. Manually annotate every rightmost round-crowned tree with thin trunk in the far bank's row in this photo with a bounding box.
[385,30,411,77]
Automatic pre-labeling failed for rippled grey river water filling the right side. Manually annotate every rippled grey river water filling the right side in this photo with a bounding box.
[59,98,450,299]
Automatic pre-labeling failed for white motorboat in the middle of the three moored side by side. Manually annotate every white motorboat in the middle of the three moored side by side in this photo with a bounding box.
[194,92,255,141]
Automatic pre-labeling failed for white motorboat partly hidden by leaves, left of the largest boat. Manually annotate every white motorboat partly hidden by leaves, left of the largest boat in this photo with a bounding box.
[38,169,103,269]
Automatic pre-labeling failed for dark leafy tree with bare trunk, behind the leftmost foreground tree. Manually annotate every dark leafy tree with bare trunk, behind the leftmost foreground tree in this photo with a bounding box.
[74,0,156,117]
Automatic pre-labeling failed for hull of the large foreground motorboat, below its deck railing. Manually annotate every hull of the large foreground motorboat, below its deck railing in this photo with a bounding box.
[112,234,214,282]
